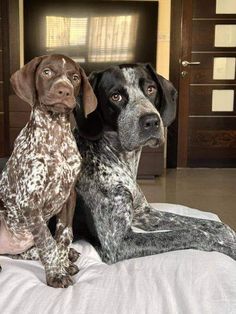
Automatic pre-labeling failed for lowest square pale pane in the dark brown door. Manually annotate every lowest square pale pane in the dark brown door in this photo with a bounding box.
[212,89,234,111]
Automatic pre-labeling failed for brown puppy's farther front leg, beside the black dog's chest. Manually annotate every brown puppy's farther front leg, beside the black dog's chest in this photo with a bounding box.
[55,188,79,275]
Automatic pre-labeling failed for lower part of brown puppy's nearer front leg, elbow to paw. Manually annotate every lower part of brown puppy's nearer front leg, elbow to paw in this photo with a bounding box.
[24,210,73,288]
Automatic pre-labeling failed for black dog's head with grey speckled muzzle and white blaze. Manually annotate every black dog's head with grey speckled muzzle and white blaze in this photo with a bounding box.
[75,64,177,151]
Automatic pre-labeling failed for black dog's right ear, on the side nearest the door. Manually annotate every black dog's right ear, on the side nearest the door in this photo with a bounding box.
[145,63,177,126]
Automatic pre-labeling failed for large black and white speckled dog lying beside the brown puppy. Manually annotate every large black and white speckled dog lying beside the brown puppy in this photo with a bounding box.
[74,64,236,263]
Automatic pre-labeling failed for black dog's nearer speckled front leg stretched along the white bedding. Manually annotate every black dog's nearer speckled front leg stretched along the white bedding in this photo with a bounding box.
[93,187,236,263]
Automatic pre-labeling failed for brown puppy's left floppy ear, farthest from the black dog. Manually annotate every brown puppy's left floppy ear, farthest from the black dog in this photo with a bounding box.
[10,57,43,106]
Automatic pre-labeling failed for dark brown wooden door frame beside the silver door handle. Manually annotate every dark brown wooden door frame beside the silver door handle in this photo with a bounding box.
[167,0,192,168]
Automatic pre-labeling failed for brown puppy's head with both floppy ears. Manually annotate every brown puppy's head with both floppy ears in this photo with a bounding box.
[11,55,97,116]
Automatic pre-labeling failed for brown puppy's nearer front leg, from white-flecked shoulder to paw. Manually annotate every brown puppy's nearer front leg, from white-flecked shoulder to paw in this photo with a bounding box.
[16,156,73,288]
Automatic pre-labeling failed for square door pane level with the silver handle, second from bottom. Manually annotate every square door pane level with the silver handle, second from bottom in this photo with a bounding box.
[213,58,235,80]
